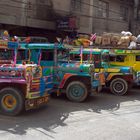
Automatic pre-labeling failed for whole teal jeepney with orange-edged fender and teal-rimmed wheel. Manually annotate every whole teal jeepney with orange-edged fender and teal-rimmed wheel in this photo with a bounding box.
[20,43,102,102]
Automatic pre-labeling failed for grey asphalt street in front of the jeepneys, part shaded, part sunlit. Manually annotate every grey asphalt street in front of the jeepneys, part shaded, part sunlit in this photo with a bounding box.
[0,88,140,140]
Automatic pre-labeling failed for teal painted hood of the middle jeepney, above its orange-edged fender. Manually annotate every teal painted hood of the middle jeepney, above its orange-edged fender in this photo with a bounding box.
[58,63,90,74]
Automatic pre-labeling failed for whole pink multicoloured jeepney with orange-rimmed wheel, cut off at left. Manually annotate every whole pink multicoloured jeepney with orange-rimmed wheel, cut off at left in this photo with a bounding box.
[0,40,49,116]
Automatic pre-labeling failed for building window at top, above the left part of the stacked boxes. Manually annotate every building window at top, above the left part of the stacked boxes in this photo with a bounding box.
[98,0,109,18]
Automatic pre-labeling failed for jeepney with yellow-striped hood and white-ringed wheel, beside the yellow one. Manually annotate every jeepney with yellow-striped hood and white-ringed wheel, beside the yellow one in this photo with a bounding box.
[70,48,133,95]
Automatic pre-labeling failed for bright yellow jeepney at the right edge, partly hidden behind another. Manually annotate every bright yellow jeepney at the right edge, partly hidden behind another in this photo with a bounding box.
[109,49,140,85]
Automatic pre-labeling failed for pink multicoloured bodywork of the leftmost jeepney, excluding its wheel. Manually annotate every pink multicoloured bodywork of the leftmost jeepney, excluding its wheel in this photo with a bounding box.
[0,40,49,110]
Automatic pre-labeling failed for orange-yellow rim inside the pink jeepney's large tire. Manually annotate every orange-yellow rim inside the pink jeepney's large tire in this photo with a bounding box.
[2,95,17,110]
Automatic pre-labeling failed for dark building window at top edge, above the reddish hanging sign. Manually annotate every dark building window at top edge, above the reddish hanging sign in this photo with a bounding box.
[71,0,82,12]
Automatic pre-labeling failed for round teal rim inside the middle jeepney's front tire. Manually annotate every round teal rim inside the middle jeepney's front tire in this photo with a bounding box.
[69,84,85,98]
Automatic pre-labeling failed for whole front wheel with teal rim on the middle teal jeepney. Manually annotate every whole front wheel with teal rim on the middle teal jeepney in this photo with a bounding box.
[66,81,88,102]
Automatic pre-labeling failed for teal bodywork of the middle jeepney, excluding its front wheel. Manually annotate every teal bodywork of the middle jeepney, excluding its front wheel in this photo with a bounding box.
[19,43,101,91]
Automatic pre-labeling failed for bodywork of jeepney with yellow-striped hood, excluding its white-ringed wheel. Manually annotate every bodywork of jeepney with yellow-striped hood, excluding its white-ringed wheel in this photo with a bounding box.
[70,48,133,82]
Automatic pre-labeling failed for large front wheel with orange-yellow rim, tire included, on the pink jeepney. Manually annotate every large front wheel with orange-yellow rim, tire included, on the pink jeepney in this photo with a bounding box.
[0,87,25,116]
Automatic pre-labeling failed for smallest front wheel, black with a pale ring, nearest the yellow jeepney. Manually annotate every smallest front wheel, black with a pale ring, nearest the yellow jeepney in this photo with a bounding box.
[110,78,128,96]
